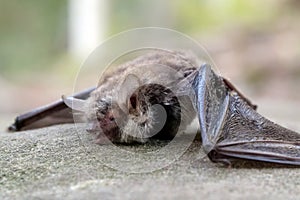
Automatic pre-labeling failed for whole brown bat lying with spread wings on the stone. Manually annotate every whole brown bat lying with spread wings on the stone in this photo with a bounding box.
[9,51,300,165]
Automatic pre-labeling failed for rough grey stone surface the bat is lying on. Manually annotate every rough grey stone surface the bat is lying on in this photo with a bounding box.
[0,100,300,200]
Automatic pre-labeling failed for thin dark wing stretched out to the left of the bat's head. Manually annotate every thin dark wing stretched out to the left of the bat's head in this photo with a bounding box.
[8,87,95,131]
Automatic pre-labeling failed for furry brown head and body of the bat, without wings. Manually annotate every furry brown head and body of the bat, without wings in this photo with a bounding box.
[63,51,197,143]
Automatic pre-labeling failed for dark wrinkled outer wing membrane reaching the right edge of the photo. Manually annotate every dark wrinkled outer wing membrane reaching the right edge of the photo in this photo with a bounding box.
[214,94,300,165]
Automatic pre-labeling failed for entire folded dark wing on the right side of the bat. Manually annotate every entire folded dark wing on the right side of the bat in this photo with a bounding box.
[194,65,300,165]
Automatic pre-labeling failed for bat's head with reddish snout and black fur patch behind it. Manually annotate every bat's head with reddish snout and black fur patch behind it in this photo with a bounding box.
[77,75,181,144]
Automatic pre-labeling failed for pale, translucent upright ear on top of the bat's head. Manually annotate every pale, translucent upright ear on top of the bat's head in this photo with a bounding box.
[117,74,141,112]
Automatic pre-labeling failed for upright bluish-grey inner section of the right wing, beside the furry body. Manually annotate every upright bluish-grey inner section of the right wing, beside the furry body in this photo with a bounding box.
[193,64,229,153]
